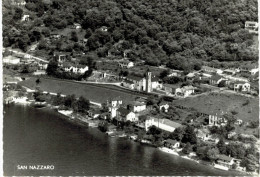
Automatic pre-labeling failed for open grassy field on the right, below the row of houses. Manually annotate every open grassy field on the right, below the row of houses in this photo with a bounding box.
[173,93,259,122]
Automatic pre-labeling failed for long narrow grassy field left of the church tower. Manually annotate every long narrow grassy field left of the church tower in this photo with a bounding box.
[19,78,147,104]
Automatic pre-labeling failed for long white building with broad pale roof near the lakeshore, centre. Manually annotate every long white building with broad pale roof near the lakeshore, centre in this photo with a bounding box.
[145,117,182,132]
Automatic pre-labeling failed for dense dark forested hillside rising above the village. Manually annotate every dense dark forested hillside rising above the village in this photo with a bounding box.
[3,0,258,69]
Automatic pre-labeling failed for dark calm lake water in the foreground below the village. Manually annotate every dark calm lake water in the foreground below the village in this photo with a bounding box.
[3,105,244,176]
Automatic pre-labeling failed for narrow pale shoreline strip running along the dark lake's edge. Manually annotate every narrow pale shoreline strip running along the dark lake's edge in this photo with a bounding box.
[3,94,258,176]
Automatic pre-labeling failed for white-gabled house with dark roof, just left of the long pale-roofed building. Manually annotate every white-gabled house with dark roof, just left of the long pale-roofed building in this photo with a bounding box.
[116,107,138,122]
